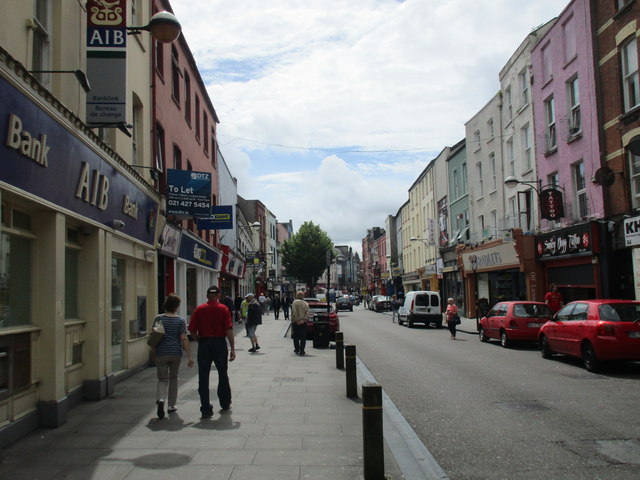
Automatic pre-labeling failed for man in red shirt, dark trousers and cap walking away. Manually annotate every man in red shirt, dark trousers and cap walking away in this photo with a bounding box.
[189,285,236,418]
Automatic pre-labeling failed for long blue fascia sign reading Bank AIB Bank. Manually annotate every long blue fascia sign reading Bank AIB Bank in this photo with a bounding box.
[0,78,158,244]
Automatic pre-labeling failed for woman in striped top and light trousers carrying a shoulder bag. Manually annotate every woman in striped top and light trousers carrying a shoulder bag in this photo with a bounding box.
[155,294,193,418]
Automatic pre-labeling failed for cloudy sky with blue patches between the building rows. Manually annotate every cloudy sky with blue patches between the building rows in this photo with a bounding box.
[170,0,568,253]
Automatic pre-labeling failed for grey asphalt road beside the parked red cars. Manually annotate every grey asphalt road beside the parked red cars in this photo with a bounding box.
[340,306,640,480]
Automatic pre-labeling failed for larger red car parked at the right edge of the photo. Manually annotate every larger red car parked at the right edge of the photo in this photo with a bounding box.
[539,300,640,372]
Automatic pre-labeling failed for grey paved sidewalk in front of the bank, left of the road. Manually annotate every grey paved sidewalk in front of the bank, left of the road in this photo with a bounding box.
[0,316,404,480]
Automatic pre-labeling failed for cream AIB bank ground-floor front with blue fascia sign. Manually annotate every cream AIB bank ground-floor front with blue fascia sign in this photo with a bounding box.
[0,63,159,445]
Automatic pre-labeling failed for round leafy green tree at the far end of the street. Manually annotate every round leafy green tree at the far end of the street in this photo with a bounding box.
[282,222,333,289]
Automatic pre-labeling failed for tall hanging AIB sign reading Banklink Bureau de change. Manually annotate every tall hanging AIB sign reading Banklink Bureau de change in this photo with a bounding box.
[87,0,127,126]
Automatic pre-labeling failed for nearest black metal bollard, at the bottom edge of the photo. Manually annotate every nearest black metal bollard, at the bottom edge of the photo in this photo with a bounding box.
[362,383,384,480]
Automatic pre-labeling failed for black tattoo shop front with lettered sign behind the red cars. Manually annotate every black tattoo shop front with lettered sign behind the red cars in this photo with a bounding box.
[536,222,602,303]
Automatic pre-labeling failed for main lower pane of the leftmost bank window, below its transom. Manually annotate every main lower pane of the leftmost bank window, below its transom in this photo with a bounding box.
[0,232,32,328]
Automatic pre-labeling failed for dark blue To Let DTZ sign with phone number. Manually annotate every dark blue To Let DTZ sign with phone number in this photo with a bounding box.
[167,169,211,217]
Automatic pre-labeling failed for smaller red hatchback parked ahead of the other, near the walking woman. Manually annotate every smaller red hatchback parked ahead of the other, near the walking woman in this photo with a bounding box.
[478,302,553,348]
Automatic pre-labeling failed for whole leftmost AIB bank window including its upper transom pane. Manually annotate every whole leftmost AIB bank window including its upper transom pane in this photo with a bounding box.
[0,204,33,328]
